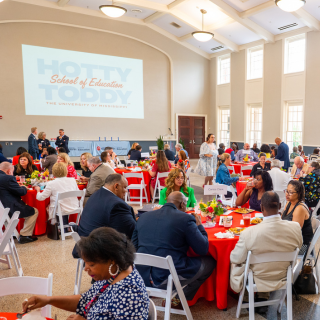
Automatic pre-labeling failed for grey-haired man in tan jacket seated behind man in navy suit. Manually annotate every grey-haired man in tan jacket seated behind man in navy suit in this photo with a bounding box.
[83,157,114,205]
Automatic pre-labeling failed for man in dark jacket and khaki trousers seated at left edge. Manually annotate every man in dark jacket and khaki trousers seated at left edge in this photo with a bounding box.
[0,162,39,244]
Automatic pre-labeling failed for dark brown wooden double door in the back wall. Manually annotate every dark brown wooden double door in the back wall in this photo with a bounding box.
[178,116,205,159]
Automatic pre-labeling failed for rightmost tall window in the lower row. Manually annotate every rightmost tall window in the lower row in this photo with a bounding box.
[287,103,303,150]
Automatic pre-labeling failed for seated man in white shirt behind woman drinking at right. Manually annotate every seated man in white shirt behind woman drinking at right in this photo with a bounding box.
[268,159,291,211]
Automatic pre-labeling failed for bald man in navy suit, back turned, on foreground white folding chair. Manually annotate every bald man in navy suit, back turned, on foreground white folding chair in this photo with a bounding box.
[132,191,216,306]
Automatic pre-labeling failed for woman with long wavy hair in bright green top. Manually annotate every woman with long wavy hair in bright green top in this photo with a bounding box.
[159,169,197,207]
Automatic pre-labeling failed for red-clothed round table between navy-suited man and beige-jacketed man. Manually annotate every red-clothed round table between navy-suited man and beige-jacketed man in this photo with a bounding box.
[188,212,257,309]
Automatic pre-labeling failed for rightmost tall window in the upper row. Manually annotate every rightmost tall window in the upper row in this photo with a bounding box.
[284,34,306,73]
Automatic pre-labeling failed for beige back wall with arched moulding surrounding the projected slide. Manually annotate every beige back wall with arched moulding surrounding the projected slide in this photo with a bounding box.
[0,1,210,140]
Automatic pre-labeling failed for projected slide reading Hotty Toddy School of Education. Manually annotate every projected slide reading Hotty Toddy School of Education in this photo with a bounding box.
[22,45,144,119]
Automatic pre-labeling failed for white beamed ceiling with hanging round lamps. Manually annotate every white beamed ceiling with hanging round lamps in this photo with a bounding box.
[43,0,320,57]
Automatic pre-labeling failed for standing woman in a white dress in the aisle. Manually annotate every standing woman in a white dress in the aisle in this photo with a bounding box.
[195,133,218,186]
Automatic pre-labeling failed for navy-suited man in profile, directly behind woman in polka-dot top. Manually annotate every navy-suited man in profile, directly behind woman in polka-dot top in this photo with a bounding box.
[72,173,136,258]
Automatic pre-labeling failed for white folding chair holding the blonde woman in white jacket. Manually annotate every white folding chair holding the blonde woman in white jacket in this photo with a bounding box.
[54,189,86,240]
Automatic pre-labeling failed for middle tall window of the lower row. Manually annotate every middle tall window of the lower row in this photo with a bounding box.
[247,104,262,147]
